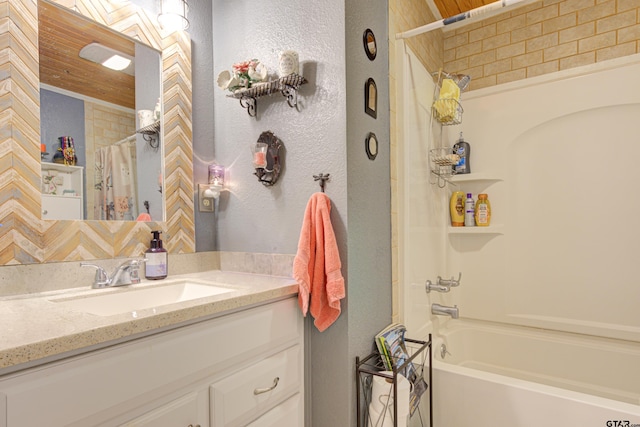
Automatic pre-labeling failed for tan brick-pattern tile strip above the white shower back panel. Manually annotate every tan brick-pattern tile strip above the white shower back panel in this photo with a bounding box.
[444,0,640,90]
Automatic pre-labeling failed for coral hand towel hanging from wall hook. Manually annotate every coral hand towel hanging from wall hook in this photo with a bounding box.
[293,193,345,332]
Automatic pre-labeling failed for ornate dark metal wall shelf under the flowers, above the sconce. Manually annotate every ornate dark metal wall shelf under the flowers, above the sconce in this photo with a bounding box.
[227,74,307,117]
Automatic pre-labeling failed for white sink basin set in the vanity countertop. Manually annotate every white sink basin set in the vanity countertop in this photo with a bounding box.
[51,280,236,317]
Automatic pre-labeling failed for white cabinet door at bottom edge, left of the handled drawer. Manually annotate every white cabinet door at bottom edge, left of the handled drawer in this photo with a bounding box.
[121,392,205,427]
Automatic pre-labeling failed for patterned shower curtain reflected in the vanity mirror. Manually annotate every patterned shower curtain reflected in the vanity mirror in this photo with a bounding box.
[94,143,137,220]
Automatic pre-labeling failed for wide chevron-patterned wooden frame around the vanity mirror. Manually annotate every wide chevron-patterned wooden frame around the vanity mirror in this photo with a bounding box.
[0,0,195,265]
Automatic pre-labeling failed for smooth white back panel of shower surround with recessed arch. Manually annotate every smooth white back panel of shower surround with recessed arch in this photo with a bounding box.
[449,55,640,344]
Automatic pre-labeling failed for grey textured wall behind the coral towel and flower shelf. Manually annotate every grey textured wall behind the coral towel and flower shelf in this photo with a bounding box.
[211,0,391,427]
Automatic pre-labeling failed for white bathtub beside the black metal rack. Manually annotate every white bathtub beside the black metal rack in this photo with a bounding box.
[433,320,640,427]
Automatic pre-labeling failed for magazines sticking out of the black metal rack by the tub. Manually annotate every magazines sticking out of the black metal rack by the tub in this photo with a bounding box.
[375,323,427,415]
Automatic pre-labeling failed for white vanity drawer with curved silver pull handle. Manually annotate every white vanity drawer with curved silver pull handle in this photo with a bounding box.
[210,345,302,427]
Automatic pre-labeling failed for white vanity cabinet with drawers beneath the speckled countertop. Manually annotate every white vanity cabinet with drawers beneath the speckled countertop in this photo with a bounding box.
[0,298,304,427]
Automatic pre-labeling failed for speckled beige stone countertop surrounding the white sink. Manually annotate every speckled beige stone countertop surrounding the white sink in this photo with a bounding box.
[0,270,298,375]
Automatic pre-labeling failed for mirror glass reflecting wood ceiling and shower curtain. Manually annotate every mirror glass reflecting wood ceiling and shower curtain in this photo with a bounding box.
[38,0,164,221]
